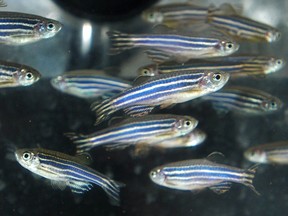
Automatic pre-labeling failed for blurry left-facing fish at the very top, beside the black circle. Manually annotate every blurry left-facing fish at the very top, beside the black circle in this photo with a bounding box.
[142,3,216,26]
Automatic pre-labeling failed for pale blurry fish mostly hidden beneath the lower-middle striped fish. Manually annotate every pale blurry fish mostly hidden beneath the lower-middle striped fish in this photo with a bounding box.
[153,128,206,149]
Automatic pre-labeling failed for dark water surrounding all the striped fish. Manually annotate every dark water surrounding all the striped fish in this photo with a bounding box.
[0,0,288,216]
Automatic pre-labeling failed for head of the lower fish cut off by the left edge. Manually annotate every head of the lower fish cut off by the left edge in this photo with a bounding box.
[15,66,41,86]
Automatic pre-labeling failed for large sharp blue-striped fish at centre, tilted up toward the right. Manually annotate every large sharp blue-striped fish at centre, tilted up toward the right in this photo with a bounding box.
[91,71,229,124]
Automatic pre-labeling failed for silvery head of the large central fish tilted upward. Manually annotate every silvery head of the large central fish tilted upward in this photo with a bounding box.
[200,71,230,93]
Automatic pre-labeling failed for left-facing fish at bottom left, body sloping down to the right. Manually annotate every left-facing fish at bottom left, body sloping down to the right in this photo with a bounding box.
[15,148,124,205]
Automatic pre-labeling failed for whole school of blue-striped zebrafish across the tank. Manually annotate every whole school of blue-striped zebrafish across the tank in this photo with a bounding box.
[0,1,288,208]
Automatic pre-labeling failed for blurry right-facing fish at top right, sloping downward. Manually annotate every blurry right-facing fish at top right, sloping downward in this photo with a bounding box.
[208,13,281,43]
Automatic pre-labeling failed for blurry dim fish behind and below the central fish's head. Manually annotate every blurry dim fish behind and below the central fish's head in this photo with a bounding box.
[201,86,283,115]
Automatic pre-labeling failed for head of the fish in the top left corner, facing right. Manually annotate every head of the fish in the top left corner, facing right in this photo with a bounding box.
[34,19,62,38]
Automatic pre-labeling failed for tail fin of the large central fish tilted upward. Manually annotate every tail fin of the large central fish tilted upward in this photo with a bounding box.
[91,98,116,125]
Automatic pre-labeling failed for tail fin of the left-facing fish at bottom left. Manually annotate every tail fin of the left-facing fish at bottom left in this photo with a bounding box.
[102,180,125,206]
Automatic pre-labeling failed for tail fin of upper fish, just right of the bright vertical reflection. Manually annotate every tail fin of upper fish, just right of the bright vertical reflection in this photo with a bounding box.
[107,31,135,55]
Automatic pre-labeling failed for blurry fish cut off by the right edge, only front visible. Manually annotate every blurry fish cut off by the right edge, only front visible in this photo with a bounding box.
[244,141,288,164]
